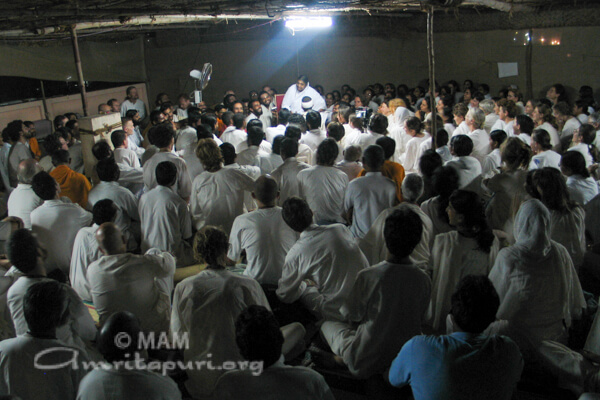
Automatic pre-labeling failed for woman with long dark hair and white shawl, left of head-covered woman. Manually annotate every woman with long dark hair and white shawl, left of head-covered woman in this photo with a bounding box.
[427,190,500,333]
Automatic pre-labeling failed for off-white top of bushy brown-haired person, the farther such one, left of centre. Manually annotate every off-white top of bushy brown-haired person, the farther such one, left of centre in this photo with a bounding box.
[190,168,254,235]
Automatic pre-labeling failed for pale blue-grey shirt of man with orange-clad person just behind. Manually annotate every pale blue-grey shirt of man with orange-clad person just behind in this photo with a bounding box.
[344,172,396,238]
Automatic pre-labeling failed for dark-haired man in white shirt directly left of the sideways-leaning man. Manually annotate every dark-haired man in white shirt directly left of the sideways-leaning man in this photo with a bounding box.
[227,175,298,285]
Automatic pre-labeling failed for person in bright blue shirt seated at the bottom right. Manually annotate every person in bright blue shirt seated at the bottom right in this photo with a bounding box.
[389,275,523,400]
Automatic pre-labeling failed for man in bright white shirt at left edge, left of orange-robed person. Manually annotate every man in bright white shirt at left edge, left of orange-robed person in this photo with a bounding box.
[8,158,44,229]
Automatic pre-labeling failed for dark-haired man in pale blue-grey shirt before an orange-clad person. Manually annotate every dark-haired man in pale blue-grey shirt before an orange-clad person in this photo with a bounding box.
[344,145,396,239]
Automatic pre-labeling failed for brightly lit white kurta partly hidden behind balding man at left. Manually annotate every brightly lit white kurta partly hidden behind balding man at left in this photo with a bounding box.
[69,224,102,302]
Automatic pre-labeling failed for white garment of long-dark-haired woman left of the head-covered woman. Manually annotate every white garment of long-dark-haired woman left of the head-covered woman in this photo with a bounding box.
[427,231,500,333]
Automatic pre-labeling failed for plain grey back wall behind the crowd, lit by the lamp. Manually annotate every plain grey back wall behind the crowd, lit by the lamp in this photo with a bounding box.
[145,27,600,103]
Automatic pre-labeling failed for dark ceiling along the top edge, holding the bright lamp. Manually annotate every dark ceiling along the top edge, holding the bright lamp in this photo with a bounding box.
[0,0,600,38]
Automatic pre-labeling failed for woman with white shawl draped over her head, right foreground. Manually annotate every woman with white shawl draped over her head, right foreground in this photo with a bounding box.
[486,199,585,358]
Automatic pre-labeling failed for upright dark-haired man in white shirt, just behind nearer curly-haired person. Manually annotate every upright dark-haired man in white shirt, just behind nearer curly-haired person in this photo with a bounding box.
[139,156,194,267]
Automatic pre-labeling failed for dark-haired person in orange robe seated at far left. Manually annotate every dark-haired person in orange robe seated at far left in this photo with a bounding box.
[50,150,92,208]
